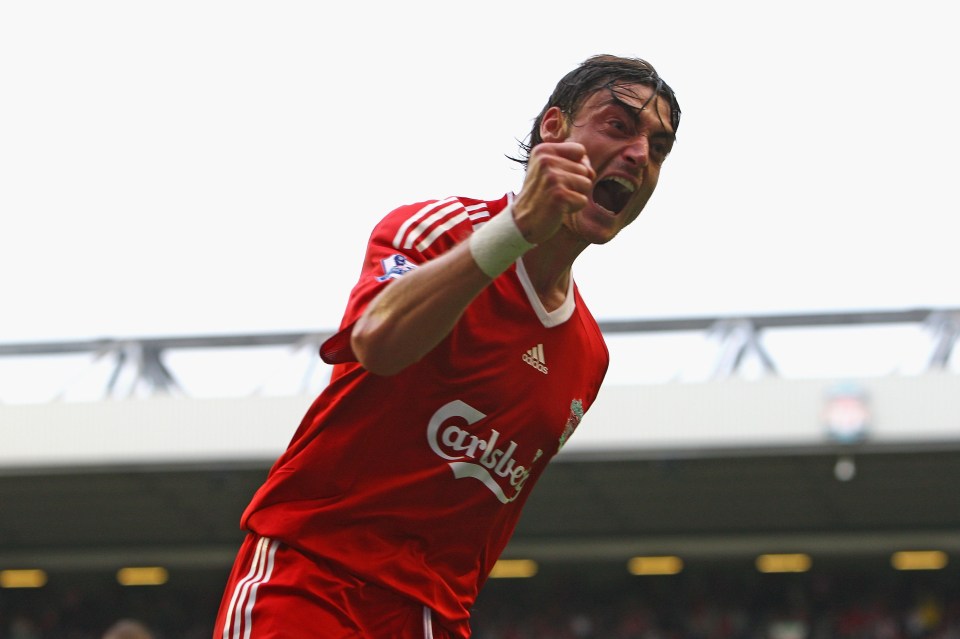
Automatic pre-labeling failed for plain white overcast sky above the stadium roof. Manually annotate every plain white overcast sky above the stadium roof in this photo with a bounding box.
[0,0,960,343]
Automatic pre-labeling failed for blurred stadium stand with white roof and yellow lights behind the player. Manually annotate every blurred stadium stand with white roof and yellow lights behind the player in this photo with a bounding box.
[0,309,960,639]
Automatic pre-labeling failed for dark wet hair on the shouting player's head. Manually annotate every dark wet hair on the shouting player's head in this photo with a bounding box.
[510,55,680,166]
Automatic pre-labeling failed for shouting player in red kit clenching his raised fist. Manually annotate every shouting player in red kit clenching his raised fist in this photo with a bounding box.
[215,56,680,639]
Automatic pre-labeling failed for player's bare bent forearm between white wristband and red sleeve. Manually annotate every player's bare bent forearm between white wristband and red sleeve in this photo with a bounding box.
[351,242,492,375]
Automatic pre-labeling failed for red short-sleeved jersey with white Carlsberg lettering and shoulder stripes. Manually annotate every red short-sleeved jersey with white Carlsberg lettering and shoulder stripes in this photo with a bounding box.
[242,194,608,636]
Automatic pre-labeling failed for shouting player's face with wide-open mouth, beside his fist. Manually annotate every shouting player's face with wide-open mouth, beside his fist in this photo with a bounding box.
[544,84,675,244]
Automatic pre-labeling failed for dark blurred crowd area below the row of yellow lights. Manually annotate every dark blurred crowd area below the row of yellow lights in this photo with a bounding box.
[0,566,960,639]
